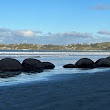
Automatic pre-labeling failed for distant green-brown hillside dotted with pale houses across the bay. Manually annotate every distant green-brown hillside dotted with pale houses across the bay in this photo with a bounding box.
[0,42,110,50]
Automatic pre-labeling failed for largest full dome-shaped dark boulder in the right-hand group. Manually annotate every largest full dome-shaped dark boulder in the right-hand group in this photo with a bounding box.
[75,58,94,68]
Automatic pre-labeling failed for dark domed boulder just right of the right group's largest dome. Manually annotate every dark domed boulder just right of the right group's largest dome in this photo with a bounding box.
[95,58,110,67]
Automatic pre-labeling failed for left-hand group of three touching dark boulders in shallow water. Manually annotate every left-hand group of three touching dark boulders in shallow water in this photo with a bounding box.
[0,58,55,78]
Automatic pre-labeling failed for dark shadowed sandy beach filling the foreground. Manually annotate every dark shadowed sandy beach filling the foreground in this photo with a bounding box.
[0,71,110,110]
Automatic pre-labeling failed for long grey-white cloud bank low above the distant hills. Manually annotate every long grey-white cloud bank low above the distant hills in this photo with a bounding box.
[0,28,109,45]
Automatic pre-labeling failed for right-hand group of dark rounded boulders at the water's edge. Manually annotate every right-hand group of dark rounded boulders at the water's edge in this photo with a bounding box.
[63,57,110,68]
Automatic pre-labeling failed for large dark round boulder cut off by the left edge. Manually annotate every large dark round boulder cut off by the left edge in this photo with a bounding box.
[0,58,23,77]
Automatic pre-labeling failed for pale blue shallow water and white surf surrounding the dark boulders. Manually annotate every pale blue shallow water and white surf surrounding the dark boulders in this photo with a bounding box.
[0,50,110,86]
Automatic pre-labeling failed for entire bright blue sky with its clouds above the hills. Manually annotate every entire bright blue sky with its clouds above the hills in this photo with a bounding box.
[0,0,110,45]
